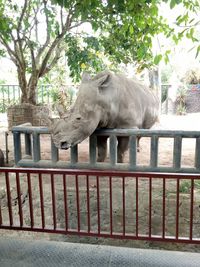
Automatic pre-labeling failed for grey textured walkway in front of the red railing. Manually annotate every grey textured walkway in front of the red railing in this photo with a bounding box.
[0,238,200,267]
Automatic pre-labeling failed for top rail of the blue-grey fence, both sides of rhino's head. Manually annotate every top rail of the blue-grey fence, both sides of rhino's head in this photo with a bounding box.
[12,123,200,138]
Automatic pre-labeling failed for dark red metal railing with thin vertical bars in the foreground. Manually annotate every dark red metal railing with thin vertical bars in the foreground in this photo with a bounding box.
[0,168,200,243]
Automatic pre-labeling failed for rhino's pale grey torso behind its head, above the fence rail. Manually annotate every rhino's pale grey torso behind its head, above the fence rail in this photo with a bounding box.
[97,74,159,128]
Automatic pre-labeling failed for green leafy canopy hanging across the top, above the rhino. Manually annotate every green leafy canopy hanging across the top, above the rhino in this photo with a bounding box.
[0,0,200,90]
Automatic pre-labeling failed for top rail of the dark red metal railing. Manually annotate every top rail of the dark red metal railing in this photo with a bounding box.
[0,167,200,179]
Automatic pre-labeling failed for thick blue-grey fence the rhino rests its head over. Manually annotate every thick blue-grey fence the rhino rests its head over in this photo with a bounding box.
[12,124,200,173]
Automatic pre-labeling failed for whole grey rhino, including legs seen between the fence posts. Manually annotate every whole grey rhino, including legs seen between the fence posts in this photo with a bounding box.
[51,71,159,162]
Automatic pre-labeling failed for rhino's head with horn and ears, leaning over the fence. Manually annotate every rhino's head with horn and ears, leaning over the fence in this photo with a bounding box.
[50,73,110,149]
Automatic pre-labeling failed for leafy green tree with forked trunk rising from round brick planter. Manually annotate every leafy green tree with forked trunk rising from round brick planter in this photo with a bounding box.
[0,0,199,104]
